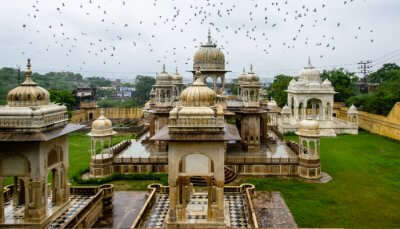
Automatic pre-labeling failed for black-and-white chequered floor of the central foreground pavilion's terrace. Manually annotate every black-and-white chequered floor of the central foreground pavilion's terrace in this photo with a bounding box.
[145,193,250,228]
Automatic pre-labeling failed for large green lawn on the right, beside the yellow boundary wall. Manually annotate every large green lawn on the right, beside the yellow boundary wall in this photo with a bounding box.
[244,132,400,228]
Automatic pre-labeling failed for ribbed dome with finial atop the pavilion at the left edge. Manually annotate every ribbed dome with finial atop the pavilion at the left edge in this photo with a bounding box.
[7,59,50,107]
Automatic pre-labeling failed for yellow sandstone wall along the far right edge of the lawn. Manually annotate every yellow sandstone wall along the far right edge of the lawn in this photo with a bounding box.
[336,102,400,141]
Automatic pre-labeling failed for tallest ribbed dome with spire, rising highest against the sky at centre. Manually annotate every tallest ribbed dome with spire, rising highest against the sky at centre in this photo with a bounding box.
[193,31,225,70]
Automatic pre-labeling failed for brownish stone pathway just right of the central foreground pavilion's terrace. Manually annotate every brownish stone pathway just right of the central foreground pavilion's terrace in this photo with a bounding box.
[253,192,297,229]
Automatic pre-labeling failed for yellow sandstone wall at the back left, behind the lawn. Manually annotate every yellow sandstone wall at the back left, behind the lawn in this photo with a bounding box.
[71,108,143,123]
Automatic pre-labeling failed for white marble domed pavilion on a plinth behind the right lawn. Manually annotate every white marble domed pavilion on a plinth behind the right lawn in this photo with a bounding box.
[278,60,358,136]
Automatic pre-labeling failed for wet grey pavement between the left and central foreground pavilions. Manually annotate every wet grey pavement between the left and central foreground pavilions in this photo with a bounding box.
[93,191,147,229]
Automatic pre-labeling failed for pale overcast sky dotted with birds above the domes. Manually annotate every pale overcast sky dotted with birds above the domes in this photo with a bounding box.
[0,0,400,80]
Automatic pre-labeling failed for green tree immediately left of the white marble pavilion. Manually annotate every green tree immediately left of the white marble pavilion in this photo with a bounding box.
[267,74,293,107]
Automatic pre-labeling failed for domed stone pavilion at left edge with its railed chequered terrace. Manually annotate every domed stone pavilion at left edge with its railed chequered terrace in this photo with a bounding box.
[0,60,113,228]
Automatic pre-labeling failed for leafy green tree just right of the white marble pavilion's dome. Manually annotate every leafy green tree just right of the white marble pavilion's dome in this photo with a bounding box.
[321,68,358,102]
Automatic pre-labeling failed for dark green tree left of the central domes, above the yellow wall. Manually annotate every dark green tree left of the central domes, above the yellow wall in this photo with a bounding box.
[132,75,156,106]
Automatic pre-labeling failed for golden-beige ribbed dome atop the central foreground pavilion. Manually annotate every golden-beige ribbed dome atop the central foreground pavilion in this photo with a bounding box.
[180,71,217,107]
